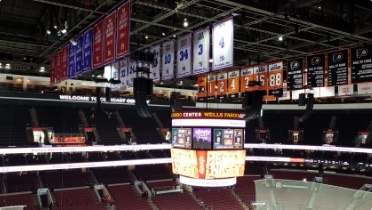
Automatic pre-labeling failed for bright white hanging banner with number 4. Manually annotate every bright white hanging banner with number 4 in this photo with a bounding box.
[212,17,234,71]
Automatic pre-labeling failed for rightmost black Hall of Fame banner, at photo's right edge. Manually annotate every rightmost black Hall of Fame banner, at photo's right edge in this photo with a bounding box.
[351,45,372,83]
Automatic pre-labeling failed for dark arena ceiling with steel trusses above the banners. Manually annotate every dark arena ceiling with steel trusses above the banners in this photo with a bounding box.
[0,0,372,79]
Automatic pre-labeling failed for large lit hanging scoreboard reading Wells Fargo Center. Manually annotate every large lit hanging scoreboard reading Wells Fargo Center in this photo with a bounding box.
[171,111,246,187]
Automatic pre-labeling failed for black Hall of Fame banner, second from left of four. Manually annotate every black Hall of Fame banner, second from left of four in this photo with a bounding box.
[306,54,325,87]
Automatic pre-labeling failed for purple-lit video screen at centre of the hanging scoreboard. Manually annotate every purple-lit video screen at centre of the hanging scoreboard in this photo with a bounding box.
[192,128,212,149]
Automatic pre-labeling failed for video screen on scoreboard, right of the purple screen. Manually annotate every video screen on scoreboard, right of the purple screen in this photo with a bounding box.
[213,128,244,149]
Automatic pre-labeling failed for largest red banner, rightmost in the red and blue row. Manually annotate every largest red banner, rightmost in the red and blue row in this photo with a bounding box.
[116,1,130,58]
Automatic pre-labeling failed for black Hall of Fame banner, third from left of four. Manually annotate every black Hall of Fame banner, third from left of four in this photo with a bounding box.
[328,49,349,86]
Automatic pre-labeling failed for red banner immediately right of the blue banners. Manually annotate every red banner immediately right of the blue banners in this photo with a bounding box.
[93,21,104,69]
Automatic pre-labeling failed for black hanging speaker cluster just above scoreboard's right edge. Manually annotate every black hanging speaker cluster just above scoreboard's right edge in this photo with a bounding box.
[243,90,264,121]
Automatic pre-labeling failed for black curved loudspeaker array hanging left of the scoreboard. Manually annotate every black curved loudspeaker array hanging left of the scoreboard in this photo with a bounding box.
[133,77,152,118]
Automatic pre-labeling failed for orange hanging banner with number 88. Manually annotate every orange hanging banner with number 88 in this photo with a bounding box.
[267,61,283,90]
